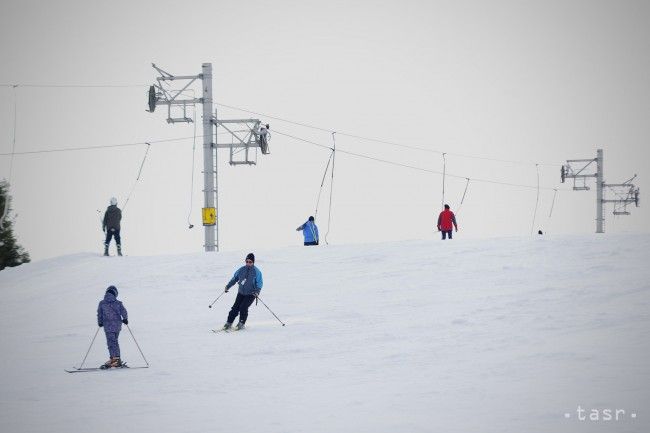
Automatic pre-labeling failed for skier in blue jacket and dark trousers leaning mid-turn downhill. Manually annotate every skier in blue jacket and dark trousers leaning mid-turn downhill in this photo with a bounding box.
[223,253,263,330]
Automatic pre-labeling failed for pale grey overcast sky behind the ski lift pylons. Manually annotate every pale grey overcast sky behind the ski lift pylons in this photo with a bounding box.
[0,0,650,259]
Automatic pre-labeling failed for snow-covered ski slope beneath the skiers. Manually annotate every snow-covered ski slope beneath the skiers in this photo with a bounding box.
[0,234,650,433]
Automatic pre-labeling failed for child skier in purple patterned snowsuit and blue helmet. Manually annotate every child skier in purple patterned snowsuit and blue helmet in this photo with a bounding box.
[97,286,129,368]
